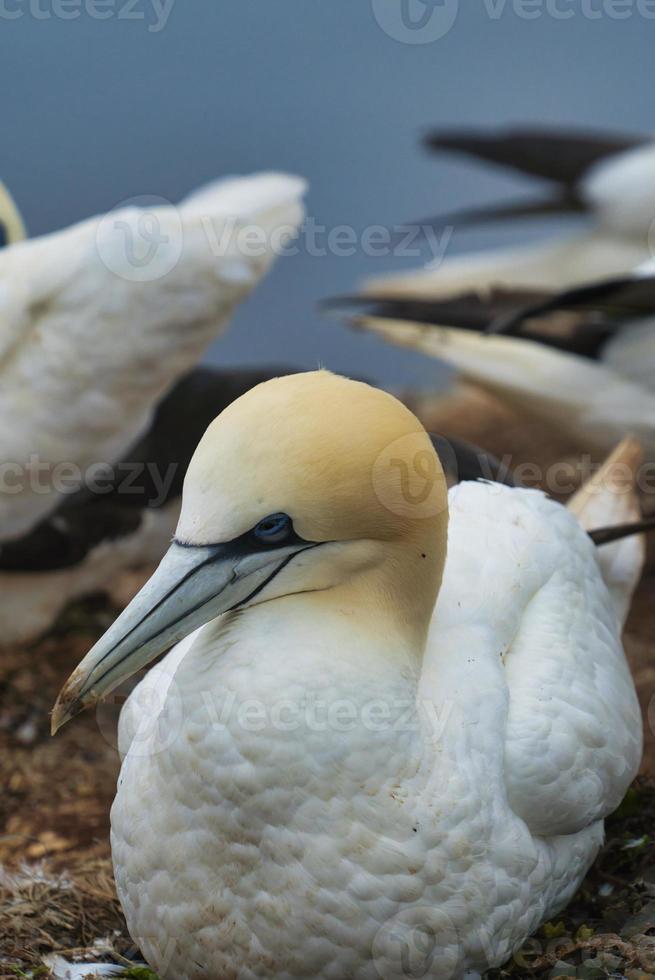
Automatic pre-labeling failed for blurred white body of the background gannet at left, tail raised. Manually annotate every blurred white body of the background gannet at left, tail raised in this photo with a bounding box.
[0,173,305,540]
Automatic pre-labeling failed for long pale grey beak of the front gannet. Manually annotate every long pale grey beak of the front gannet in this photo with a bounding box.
[51,542,312,735]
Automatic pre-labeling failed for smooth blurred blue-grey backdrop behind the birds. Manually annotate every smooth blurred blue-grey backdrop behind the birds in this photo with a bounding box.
[0,0,655,384]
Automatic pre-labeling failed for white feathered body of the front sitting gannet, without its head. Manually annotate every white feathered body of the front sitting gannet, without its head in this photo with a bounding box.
[112,483,641,980]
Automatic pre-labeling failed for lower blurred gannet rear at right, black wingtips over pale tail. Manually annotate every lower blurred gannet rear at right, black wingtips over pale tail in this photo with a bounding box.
[328,263,655,459]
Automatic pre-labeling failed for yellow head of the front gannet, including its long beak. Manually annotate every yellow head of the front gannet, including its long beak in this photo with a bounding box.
[53,371,447,728]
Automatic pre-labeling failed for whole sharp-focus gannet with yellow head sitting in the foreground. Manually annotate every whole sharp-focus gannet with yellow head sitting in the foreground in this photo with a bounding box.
[53,372,641,980]
